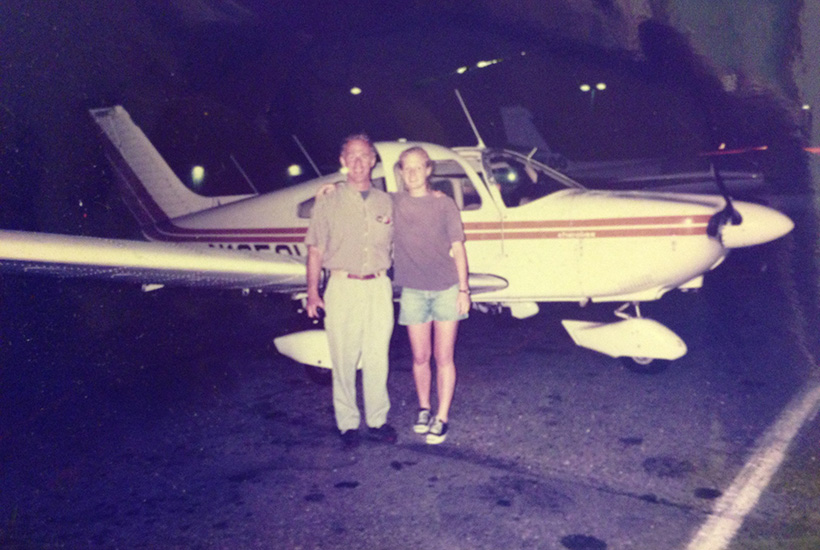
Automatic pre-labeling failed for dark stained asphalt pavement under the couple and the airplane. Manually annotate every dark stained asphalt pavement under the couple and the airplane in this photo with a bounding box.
[0,230,820,550]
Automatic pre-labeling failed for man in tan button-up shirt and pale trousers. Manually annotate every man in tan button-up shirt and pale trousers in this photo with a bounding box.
[305,134,397,448]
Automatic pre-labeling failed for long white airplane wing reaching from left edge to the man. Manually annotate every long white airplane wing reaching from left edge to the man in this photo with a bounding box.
[0,230,306,292]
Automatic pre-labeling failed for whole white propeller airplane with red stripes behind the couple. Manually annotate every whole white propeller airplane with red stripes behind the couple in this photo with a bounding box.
[0,101,793,374]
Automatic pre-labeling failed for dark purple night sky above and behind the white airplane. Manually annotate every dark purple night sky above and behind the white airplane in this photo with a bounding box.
[0,0,808,236]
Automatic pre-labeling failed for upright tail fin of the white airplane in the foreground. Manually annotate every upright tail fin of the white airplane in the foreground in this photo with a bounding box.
[90,105,245,227]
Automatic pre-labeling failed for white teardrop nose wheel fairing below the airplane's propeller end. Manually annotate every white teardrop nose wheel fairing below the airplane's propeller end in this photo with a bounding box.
[561,317,686,361]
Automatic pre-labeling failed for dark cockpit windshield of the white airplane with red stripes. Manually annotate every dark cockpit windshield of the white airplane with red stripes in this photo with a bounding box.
[482,150,583,208]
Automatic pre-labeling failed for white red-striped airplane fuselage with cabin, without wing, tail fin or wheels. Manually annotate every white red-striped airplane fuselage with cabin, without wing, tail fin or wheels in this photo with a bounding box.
[146,142,791,303]
